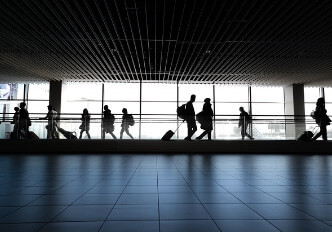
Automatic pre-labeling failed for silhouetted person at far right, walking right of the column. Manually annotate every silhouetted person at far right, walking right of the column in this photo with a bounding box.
[312,97,331,141]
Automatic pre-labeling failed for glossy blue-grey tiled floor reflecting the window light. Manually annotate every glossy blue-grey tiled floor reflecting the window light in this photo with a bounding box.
[0,155,332,232]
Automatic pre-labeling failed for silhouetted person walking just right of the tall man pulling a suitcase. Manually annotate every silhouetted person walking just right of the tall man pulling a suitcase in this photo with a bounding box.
[196,98,213,140]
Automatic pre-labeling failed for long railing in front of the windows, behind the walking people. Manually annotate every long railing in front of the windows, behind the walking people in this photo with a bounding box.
[0,113,326,140]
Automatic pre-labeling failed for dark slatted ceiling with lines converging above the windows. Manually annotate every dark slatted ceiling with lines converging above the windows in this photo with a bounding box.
[0,0,332,86]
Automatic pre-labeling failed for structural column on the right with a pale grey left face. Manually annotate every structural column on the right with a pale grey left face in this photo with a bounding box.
[284,84,306,139]
